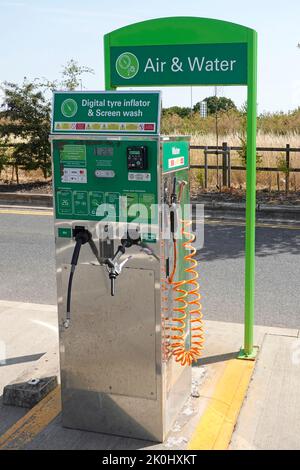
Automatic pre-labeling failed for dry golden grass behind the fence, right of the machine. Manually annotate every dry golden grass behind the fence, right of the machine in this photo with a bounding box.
[162,108,300,190]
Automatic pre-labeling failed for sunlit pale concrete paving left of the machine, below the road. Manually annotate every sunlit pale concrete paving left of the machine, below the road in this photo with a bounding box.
[0,301,59,396]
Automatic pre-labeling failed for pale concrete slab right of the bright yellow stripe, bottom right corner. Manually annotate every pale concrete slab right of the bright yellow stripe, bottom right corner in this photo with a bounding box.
[230,334,300,450]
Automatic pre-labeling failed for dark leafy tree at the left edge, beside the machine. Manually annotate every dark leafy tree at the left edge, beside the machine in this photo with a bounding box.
[0,78,51,183]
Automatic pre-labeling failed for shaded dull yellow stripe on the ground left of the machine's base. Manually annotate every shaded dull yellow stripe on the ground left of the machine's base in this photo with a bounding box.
[0,387,61,450]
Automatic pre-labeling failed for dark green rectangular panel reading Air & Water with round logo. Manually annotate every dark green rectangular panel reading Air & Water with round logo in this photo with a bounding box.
[110,43,247,86]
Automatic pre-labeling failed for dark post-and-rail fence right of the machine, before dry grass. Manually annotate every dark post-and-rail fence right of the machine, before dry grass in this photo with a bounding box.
[190,142,300,192]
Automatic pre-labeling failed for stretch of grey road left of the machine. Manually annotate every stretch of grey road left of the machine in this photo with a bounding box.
[0,211,56,304]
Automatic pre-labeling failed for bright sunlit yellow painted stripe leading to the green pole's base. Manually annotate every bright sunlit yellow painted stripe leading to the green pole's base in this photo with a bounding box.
[188,359,255,450]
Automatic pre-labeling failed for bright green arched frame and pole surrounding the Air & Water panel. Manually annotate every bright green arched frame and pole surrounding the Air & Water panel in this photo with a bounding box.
[104,17,257,359]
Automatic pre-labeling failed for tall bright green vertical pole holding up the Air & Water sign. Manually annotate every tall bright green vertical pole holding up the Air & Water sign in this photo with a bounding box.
[239,31,257,359]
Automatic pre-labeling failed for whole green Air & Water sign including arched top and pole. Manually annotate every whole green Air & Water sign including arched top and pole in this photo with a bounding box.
[104,17,257,359]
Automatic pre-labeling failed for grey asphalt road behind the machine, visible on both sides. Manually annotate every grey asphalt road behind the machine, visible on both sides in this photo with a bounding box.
[0,210,300,328]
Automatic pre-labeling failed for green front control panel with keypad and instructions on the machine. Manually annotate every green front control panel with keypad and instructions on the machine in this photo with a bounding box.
[53,137,158,222]
